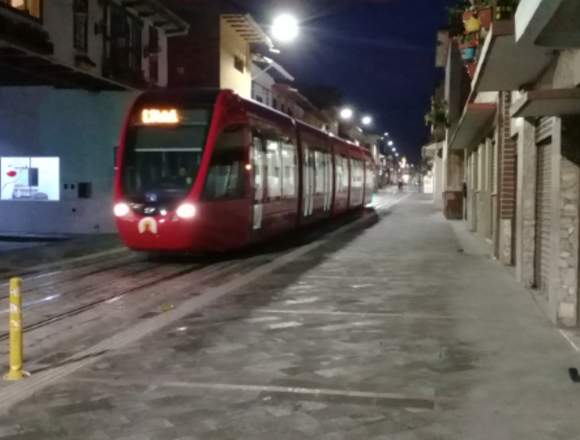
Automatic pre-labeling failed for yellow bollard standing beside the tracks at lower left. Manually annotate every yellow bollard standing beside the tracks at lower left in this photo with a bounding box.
[4,278,29,380]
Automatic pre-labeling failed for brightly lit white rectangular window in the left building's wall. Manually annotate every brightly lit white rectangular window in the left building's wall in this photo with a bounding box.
[0,157,60,201]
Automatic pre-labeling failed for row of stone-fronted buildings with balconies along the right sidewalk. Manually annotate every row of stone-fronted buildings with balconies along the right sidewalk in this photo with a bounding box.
[430,0,580,326]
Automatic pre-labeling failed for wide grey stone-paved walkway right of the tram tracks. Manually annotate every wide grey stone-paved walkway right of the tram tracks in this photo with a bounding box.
[0,195,580,440]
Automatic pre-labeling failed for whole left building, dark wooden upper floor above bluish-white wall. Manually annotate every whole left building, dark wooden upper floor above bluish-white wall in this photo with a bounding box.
[0,0,188,234]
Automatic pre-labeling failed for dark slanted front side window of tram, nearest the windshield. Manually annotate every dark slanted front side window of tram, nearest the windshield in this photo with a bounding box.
[203,127,246,200]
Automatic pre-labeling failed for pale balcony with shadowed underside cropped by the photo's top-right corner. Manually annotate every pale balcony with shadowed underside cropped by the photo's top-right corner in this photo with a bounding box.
[515,0,580,49]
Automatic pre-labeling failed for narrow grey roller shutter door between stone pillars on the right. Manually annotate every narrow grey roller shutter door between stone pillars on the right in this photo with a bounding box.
[535,120,553,293]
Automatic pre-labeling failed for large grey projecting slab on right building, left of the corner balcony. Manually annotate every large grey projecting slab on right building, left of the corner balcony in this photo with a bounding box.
[472,20,554,96]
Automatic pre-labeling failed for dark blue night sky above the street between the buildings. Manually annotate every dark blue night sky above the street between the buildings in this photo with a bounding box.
[238,0,454,161]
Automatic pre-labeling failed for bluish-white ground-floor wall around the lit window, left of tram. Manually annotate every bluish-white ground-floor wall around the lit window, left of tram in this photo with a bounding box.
[0,87,135,234]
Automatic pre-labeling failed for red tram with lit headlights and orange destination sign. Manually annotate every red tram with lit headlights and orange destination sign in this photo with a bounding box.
[114,90,375,252]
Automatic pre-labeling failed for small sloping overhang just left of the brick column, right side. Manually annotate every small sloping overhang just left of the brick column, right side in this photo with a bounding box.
[449,103,497,150]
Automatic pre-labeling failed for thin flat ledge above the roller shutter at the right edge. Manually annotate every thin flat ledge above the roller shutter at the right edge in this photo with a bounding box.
[512,88,580,118]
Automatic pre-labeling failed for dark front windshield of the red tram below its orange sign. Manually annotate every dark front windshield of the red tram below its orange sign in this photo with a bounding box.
[123,110,211,202]
